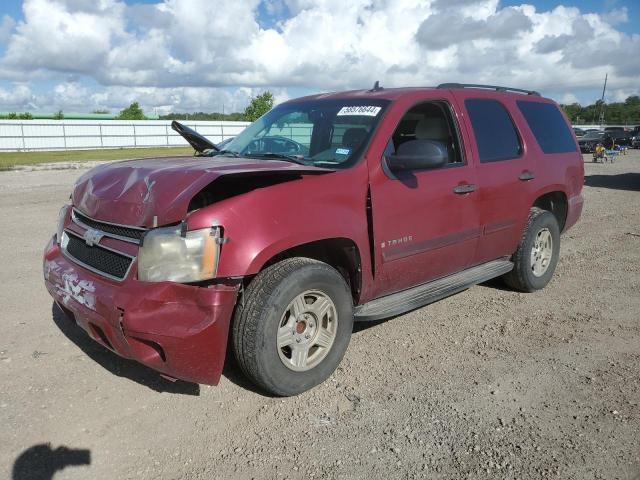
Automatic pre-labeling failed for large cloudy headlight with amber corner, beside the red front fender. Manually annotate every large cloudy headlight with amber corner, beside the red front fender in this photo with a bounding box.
[138,225,221,283]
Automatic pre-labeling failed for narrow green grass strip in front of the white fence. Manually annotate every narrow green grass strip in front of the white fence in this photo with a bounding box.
[0,147,193,170]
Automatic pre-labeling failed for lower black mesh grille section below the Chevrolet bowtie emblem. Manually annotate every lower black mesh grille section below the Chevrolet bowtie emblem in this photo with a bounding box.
[63,231,133,280]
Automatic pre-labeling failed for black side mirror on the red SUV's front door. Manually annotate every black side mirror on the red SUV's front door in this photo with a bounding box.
[387,140,449,172]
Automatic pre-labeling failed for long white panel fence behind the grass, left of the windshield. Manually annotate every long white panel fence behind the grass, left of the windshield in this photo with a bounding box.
[0,120,249,151]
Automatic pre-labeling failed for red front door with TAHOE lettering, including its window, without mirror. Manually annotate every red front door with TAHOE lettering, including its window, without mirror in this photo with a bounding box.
[369,97,480,296]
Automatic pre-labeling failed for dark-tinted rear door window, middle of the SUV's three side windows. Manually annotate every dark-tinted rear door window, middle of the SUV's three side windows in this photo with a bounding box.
[464,98,522,163]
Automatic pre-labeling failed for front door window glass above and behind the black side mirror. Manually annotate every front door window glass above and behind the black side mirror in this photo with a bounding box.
[385,102,464,166]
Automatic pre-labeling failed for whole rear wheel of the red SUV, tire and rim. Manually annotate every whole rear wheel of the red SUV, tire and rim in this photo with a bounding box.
[503,207,560,292]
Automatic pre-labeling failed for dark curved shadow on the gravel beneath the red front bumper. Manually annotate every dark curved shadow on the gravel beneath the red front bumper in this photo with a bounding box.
[51,302,200,396]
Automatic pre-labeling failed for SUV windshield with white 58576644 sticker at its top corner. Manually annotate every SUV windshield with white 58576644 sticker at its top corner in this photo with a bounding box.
[223,99,389,168]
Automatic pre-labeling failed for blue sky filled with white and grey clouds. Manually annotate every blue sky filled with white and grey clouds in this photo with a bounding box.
[0,0,640,114]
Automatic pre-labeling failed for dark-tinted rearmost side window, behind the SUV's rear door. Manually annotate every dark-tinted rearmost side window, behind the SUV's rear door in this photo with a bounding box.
[516,101,577,153]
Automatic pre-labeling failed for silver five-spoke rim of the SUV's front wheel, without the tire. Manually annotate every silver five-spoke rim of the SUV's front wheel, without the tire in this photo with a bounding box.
[276,290,338,372]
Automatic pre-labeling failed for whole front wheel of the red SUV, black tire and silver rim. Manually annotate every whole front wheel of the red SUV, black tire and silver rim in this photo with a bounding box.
[232,258,353,396]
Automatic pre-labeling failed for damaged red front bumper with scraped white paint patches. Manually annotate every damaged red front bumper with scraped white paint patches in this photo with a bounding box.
[43,237,239,385]
